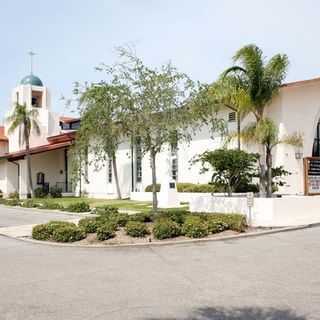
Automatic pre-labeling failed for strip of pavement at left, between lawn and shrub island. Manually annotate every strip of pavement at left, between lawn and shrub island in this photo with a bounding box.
[0,206,78,228]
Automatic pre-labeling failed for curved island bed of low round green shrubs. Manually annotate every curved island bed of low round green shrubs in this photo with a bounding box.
[32,207,247,244]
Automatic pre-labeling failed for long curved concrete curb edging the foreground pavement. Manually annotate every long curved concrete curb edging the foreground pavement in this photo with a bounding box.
[1,223,320,249]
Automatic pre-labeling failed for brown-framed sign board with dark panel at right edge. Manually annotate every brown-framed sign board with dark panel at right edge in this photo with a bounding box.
[303,157,320,195]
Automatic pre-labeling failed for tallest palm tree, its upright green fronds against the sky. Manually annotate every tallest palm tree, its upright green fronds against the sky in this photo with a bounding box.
[225,45,289,195]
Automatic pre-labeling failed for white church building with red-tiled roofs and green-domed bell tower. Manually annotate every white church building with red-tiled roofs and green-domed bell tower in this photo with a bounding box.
[0,74,320,198]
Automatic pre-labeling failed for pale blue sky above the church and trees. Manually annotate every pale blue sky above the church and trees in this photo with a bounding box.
[0,0,320,118]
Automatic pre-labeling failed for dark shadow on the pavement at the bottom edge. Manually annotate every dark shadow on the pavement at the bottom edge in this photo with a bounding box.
[145,307,307,320]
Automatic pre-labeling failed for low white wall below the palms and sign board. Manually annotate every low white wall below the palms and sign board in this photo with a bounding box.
[189,195,320,227]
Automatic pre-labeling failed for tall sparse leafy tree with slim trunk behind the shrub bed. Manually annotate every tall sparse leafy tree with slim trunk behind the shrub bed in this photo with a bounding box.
[108,49,195,211]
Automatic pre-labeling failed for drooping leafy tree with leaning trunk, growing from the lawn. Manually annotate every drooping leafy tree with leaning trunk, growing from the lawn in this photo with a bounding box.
[74,82,130,199]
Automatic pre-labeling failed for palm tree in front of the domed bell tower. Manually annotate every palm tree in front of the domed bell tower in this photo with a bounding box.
[7,103,40,198]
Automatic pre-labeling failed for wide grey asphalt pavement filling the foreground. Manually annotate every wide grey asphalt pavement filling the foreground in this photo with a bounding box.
[0,228,320,320]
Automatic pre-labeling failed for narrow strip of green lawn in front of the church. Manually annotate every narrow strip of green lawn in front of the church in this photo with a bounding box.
[35,197,188,212]
